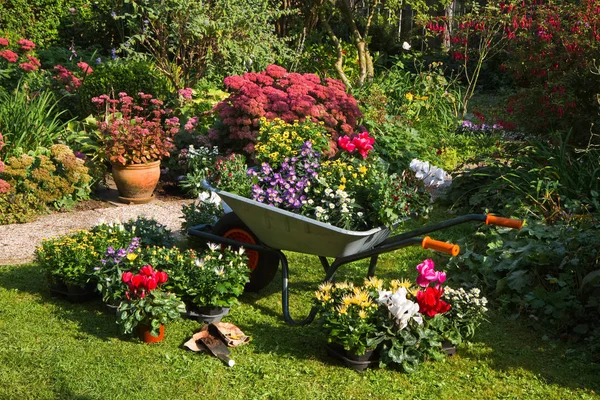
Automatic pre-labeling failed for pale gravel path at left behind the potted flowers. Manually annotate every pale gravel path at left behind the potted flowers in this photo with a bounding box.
[0,200,191,265]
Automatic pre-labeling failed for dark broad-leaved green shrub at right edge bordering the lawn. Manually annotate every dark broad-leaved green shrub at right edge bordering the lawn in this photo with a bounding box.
[447,223,600,334]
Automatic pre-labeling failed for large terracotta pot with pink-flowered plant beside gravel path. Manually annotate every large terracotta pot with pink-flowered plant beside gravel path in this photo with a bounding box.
[92,92,179,204]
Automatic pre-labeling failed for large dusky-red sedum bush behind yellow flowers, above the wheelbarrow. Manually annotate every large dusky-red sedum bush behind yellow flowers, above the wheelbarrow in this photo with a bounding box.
[209,65,362,154]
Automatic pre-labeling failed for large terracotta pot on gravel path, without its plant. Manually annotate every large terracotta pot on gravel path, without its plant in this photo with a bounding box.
[112,161,160,204]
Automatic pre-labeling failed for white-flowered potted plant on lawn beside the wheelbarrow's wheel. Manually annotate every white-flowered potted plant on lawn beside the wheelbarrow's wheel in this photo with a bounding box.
[186,243,251,323]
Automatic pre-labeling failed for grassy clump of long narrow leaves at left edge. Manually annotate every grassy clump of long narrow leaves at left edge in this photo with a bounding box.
[0,86,66,161]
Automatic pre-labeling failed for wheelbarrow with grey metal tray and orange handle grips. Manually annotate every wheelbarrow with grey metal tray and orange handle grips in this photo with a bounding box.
[188,183,523,325]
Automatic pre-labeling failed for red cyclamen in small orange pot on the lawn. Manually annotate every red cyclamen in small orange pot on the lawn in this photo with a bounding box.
[117,265,185,343]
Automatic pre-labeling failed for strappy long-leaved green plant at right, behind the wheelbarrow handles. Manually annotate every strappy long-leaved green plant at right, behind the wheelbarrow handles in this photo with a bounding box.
[449,134,600,223]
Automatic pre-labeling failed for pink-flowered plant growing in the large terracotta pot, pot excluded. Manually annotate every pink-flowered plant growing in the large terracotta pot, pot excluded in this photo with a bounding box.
[92,92,179,165]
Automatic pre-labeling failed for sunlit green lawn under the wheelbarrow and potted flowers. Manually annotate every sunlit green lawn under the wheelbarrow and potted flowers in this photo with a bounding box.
[0,211,600,400]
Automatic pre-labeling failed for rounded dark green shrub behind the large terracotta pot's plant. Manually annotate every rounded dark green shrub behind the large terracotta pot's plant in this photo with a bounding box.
[79,59,172,117]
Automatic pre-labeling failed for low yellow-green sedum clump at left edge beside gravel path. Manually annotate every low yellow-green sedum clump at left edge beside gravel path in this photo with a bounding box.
[0,144,91,224]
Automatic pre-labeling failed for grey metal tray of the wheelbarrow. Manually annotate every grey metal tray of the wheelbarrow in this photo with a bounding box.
[212,189,390,257]
